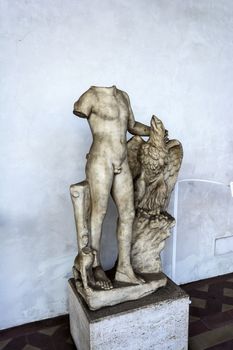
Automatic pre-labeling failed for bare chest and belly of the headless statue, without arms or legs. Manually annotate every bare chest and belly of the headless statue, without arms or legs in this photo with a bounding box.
[88,87,129,166]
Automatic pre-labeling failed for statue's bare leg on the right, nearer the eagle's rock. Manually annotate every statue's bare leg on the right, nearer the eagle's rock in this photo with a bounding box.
[112,161,144,284]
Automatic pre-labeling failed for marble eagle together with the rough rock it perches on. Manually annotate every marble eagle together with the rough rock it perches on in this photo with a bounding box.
[127,116,183,273]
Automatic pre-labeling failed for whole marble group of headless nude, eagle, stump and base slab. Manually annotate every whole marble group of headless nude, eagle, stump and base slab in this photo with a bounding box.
[70,86,182,309]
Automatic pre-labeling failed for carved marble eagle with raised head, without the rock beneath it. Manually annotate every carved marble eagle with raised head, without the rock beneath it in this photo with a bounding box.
[128,116,183,216]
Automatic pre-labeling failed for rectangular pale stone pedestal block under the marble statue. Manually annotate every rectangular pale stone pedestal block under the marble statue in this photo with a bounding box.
[69,279,189,350]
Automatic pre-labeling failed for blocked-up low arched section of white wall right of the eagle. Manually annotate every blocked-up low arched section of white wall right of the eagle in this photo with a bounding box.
[163,179,233,284]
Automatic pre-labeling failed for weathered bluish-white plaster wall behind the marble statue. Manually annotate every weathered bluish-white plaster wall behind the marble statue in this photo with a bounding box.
[0,0,233,328]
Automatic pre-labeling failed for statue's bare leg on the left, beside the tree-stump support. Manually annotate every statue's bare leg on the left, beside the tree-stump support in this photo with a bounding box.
[86,157,113,289]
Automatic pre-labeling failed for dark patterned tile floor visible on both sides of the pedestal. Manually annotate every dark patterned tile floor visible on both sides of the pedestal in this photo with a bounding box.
[0,273,233,350]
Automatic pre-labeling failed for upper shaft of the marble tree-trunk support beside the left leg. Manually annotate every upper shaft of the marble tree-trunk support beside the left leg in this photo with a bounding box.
[70,180,91,251]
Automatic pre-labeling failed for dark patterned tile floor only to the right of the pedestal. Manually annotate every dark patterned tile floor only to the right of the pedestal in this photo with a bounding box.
[182,273,233,350]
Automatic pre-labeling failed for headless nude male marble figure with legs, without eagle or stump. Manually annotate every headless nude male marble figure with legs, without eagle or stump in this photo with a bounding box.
[74,86,150,289]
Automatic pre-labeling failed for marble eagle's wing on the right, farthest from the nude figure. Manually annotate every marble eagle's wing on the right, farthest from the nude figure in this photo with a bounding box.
[164,140,183,209]
